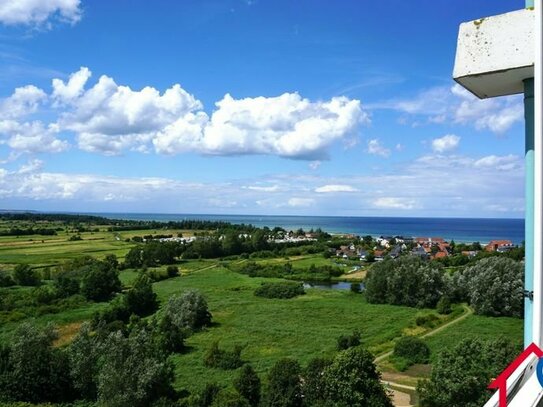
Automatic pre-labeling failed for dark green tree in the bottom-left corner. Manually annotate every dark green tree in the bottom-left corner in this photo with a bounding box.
[0,323,74,403]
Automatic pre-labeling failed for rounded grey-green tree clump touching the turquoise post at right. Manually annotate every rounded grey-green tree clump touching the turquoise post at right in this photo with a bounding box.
[453,257,524,318]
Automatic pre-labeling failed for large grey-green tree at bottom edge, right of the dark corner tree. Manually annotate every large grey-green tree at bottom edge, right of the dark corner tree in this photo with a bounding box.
[98,329,173,407]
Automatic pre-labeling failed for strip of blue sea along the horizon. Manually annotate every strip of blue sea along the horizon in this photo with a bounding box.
[93,213,524,244]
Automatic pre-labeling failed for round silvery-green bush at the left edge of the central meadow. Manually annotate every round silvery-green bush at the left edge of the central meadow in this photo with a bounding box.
[164,290,211,330]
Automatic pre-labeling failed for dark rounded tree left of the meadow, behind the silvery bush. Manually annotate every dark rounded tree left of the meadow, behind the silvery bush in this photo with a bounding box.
[81,266,121,301]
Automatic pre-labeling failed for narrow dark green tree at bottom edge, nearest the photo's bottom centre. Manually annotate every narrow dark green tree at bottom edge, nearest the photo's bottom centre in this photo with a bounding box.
[264,359,303,407]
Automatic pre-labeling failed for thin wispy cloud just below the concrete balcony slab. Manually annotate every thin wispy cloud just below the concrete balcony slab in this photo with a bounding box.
[371,84,524,134]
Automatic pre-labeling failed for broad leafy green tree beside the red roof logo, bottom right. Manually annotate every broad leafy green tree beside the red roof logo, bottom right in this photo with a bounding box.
[417,339,521,407]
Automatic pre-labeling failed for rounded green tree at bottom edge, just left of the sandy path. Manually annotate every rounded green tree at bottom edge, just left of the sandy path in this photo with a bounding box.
[323,347,393,407]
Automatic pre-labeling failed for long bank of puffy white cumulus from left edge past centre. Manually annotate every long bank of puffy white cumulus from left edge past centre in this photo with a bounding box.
[0,67,369,161]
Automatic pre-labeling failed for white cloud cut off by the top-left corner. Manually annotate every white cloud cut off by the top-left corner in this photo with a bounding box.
[0,0,81,26]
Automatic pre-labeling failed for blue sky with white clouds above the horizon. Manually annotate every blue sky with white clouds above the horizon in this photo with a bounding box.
[0,0,524,218]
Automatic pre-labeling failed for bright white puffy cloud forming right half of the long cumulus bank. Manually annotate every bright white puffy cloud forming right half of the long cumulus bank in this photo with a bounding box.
[158,93,368,160]
